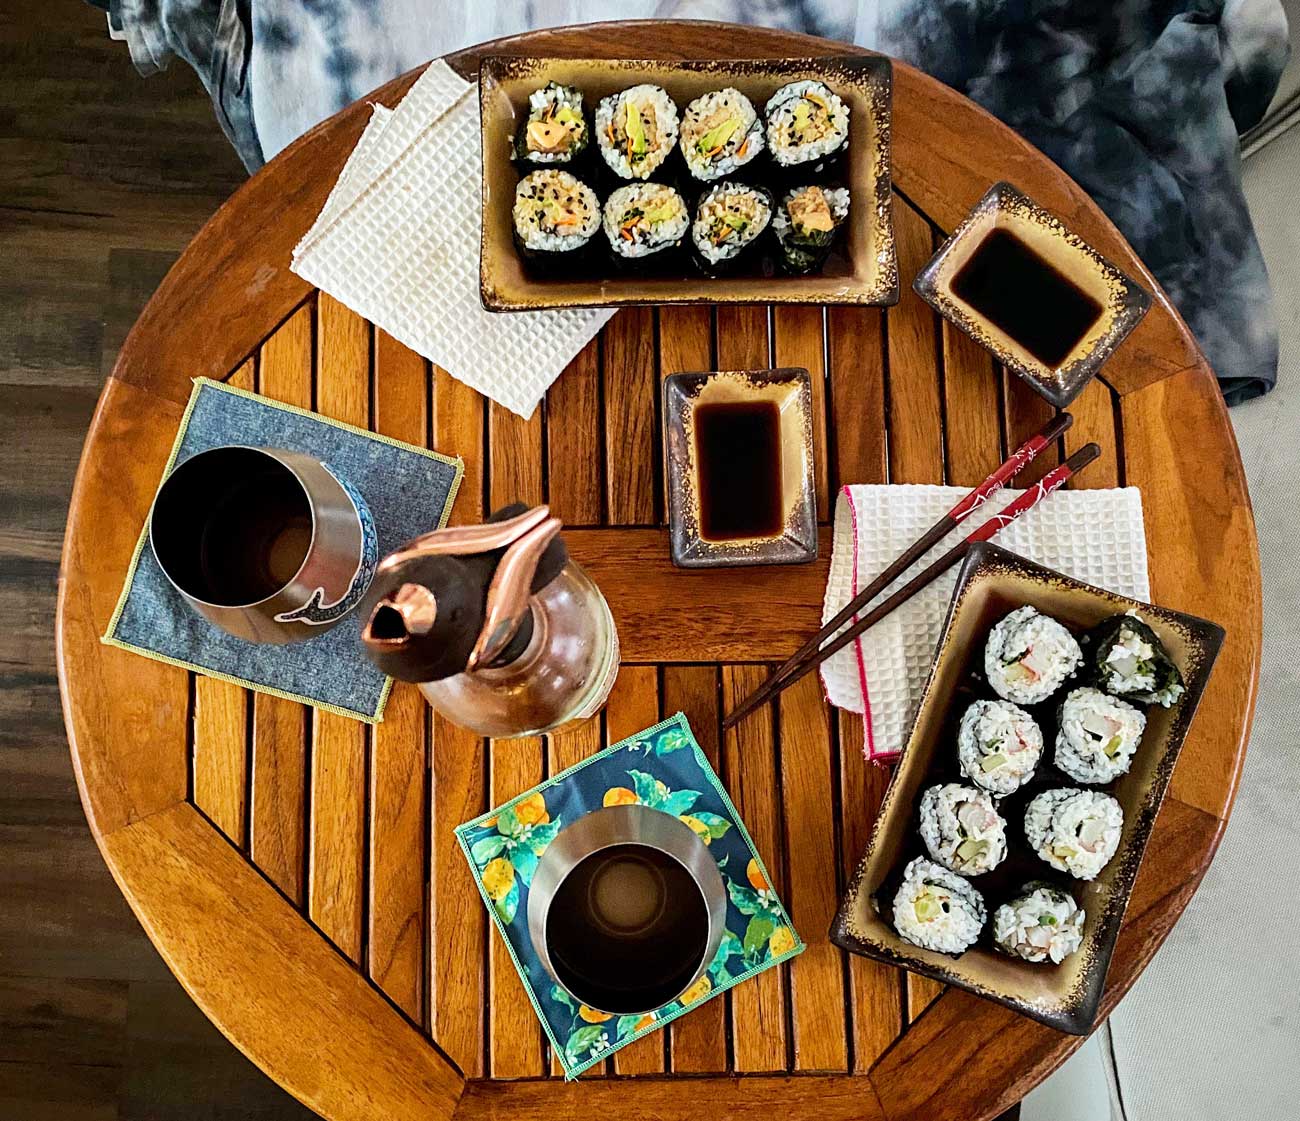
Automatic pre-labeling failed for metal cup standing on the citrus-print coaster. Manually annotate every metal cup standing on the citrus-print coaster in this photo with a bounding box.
[528,805,727,1016]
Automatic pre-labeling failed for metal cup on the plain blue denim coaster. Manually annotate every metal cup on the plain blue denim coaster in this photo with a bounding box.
[150,446,378,644]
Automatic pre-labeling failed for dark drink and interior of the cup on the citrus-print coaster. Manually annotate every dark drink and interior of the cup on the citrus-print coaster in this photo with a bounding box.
[546,844,709,1014]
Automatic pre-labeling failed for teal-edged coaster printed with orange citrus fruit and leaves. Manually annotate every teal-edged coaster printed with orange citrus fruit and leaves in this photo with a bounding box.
[456,713,803,1078]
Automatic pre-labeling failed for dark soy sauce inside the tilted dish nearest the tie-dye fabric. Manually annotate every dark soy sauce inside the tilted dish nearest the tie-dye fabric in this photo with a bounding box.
[952,229,1101,368]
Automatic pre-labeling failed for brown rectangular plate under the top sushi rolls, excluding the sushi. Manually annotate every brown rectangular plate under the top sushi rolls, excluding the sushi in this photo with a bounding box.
[478,55,898,311]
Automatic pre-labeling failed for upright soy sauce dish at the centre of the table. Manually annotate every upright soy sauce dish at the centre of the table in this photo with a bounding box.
[663,367,818,568]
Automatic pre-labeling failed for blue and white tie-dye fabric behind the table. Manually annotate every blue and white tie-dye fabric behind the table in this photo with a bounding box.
[111,0,1287,403]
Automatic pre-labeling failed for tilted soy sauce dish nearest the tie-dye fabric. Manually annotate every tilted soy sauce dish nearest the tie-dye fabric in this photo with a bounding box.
[913,183,1151,408]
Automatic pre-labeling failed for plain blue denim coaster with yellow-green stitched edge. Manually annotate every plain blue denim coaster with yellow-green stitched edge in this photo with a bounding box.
[104,377,464,723]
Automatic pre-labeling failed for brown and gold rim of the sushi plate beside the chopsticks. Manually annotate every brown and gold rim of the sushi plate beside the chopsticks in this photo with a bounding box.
[831,542,1223,1035]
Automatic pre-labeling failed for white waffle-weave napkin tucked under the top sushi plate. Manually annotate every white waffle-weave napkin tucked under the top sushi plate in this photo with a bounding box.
[290,61,614,416]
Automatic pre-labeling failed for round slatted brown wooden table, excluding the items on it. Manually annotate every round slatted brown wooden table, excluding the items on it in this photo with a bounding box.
[57,23,1260,1121]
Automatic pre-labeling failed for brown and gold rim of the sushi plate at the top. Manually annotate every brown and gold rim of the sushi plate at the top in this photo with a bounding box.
[478,55,898,311]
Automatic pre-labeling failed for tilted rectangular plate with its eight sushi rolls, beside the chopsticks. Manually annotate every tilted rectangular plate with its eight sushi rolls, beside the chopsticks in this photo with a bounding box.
[831,544,1223,1035]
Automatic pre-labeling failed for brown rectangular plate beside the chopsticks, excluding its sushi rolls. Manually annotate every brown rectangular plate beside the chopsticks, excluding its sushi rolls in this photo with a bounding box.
[831,544,1223,1035]
